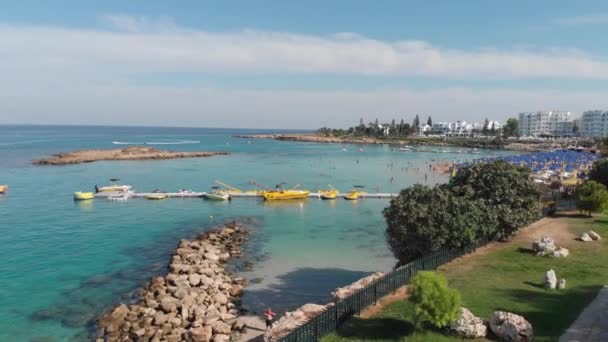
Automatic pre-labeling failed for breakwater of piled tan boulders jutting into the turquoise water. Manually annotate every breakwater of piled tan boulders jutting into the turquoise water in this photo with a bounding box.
[97,224,248,342]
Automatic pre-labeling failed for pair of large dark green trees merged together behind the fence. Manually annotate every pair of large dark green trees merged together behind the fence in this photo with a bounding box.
[383,161,542,264]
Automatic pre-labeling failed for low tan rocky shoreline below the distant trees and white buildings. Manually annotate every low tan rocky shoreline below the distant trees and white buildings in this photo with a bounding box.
[233,134,563,152]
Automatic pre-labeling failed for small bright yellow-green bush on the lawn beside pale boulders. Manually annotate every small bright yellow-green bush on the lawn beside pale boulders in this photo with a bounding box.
[408,271,460,328]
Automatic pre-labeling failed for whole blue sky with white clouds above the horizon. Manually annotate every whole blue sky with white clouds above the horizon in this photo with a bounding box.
[0,0,608,128]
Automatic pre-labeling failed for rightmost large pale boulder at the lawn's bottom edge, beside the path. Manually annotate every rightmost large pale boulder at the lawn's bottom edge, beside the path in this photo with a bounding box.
[489,311,534,342]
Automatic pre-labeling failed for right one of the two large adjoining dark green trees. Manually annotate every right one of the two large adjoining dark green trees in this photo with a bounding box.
[452,160,542,239]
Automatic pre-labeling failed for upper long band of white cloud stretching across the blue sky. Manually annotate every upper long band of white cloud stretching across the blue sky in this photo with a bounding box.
[0,15,608,80]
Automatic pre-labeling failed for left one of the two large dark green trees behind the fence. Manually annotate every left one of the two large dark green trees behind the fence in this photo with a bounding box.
[383,184,497,265]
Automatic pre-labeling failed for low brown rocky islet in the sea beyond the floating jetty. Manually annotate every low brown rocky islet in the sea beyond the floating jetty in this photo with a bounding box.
[32,146,230,166]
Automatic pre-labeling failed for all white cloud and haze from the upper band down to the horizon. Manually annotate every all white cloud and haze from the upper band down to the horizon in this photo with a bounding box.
[0,16,608,128]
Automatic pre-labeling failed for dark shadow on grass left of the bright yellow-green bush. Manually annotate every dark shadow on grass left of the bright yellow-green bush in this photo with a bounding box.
[337,317,414,340]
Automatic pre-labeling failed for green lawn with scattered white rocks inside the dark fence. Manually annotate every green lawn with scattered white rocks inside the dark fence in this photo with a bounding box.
[323,217,608,342]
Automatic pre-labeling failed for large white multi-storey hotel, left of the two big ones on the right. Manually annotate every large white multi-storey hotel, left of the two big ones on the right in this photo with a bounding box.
[519,111,575,137]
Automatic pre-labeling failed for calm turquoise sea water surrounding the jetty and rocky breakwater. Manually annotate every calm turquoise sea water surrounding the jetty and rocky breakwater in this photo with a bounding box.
[0,126,508,341]
